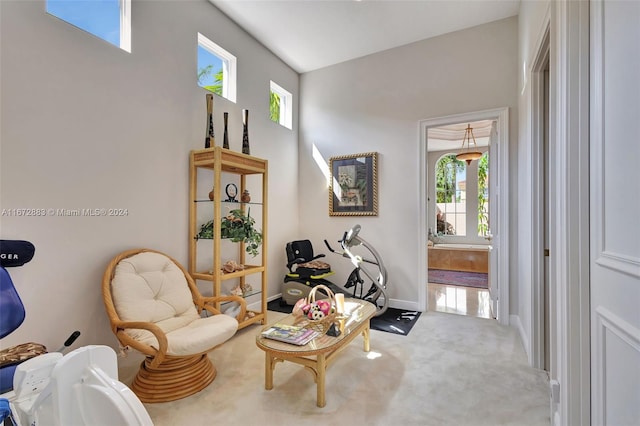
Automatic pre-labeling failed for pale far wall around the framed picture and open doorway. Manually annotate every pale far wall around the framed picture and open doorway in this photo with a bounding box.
[299,17,518,311]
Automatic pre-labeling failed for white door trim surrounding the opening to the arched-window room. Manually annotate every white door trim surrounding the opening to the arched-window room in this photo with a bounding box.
[418,107,510,325]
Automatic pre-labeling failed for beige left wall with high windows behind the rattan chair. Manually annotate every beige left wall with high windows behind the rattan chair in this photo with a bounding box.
[0,0,299,348]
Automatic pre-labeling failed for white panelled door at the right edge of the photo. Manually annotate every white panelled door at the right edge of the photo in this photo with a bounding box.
[590,0,640,425]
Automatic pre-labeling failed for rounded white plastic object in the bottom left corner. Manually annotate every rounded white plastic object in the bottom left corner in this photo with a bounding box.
[10,346,153,426]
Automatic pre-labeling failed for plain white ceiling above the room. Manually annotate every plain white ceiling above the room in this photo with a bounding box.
[209,0,520,73]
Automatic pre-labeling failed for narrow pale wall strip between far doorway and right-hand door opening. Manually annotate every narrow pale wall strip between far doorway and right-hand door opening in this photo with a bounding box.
[514,1,549,360]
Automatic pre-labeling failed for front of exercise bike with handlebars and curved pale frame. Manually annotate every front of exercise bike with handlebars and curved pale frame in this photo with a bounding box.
[324,225,389,316]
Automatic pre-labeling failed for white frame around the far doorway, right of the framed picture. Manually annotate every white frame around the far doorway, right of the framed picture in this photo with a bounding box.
[418,108,509,325]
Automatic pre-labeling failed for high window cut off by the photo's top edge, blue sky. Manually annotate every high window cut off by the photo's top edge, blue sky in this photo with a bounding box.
[46,0,131,52]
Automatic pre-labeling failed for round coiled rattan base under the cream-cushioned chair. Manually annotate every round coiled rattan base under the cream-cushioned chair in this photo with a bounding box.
[131,354,216,402]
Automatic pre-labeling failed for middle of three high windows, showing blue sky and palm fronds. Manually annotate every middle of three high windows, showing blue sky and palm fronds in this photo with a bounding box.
[198,33,236,102]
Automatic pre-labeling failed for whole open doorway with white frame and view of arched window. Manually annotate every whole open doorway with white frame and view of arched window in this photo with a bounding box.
[420,109,509,324]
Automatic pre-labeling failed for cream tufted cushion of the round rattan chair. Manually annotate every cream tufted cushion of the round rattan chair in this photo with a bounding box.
[111,252,238,355]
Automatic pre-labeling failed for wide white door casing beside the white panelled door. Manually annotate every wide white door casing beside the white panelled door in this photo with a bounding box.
[549,0,591,426]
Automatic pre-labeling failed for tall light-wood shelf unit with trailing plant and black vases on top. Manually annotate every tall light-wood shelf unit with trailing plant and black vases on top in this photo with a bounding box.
[189,146,268,328]
